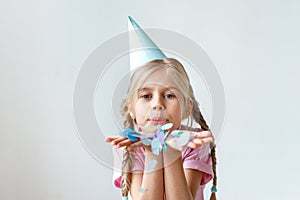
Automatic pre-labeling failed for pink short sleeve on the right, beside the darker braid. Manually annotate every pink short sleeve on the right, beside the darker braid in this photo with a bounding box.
[182,144,214,185]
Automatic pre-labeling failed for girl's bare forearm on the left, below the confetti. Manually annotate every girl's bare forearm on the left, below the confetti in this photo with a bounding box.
[130,150,164,200]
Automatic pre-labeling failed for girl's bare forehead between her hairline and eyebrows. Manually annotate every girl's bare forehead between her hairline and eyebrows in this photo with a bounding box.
[141,69,176,88]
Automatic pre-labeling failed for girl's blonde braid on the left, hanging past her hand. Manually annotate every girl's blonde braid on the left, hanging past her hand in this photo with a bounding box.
[121,101,133,200]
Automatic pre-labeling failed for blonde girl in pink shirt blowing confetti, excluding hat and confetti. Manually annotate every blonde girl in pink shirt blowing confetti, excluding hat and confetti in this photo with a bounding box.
[107,58,217,200]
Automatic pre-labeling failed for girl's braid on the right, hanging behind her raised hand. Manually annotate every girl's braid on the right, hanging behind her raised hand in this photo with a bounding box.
[192,95,217,200]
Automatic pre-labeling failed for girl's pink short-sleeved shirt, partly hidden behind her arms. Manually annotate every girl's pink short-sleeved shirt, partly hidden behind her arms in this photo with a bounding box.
[113,144,213,200]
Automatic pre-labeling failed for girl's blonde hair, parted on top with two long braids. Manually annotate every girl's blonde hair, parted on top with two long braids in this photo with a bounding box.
[121,58,217,200]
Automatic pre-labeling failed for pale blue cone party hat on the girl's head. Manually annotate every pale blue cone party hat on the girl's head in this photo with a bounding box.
[128,16,166,70]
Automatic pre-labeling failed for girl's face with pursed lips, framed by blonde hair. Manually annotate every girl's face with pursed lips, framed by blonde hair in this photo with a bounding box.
[131,69,183,129]
